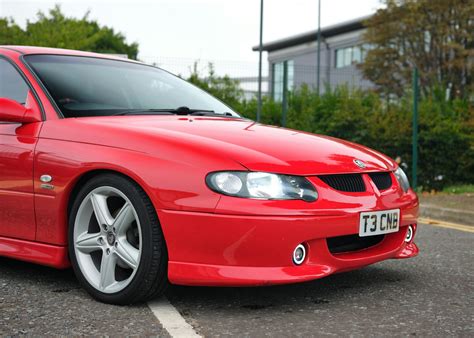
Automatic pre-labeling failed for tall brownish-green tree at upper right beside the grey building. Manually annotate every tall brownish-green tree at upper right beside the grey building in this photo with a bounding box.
[361,0,474,99]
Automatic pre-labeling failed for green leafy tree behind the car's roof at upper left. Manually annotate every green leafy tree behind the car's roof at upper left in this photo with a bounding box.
[0,6,138,59]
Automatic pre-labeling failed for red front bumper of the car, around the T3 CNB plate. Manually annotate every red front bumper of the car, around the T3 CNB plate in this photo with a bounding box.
[158,200,418,286]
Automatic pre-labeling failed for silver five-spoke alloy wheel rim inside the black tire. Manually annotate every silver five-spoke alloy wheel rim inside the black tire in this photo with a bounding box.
[73,186,142,294]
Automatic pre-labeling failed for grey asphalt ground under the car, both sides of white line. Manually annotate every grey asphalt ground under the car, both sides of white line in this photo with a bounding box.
[0,220,474,337]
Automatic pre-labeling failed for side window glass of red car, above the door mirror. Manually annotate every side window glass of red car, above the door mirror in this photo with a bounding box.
[0,58,29,105]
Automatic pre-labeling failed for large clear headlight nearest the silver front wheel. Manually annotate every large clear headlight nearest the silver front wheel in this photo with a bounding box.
[206,171,318,202]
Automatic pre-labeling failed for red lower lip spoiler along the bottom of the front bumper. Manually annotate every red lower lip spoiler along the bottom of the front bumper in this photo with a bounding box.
[168,242,419,287]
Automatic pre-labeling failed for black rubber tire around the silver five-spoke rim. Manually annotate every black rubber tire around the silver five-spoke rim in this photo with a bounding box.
[68,174,168,305]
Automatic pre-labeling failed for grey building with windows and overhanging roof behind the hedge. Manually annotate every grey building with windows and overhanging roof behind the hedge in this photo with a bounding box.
[253,17,372,100]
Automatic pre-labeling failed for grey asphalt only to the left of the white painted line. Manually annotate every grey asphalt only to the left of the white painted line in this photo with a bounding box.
[0,258,167,337]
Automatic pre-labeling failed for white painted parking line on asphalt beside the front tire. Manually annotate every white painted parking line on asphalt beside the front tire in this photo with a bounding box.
[148,297,201,338]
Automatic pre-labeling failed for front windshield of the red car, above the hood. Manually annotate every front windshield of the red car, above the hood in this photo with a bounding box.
[25,55,239,118]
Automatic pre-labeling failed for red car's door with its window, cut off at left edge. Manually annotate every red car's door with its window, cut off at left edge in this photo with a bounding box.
[0,55,42,240]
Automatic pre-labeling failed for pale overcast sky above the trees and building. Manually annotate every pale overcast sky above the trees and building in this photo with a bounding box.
[0,0,379,62]
